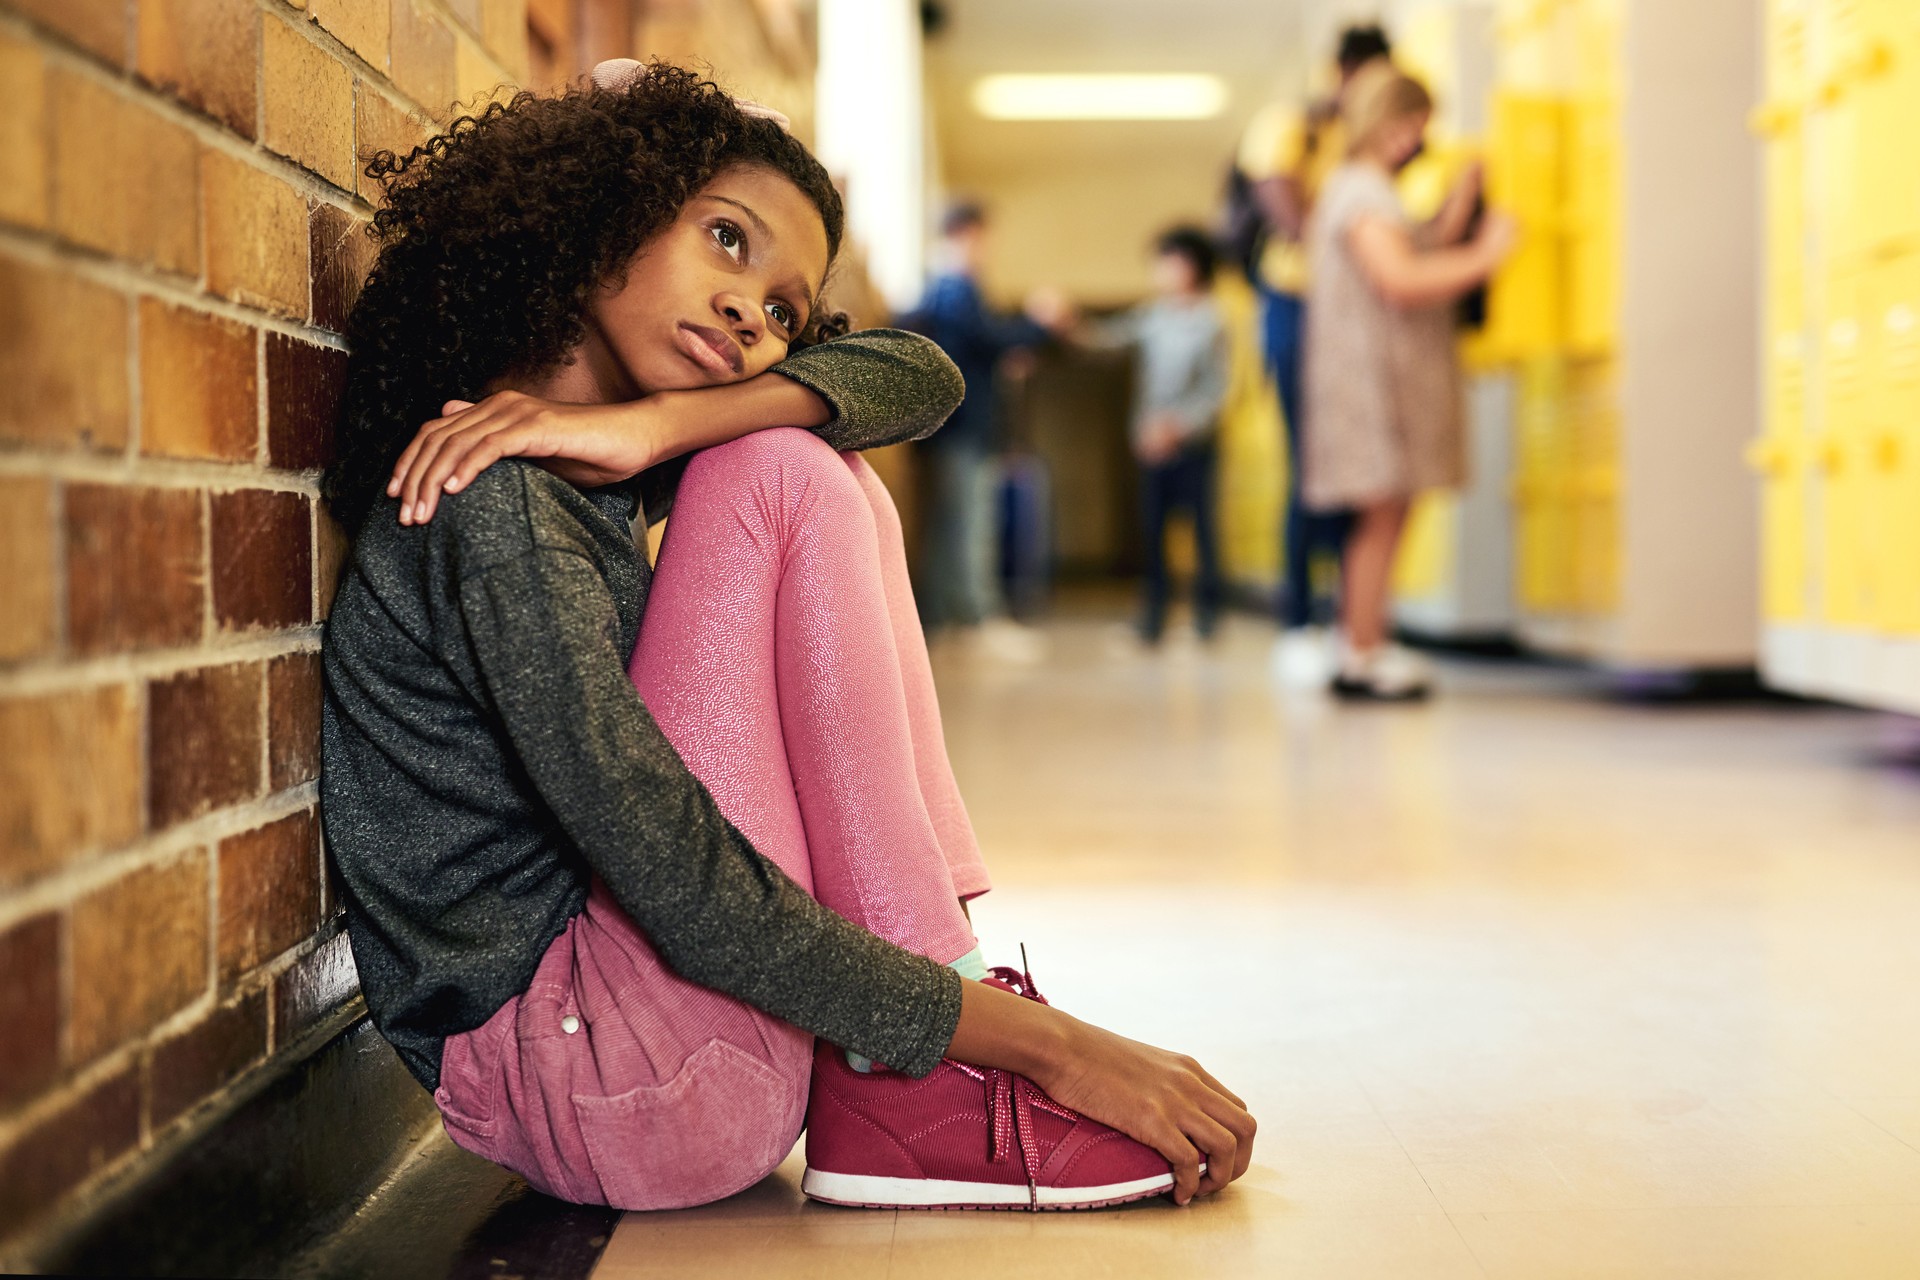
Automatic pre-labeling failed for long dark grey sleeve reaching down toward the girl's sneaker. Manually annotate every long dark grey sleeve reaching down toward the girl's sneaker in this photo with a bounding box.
[459,525,960,1075]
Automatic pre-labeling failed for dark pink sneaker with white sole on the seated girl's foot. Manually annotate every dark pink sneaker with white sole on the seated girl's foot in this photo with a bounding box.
[801,967,1173,1211]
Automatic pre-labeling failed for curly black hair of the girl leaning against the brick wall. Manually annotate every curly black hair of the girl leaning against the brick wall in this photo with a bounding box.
[323,63,847,532]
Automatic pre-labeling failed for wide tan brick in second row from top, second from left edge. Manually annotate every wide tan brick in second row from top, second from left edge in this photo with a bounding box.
[52,69,200,276]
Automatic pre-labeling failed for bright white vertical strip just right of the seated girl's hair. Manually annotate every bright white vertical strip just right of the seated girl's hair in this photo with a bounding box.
[814,0,927,309]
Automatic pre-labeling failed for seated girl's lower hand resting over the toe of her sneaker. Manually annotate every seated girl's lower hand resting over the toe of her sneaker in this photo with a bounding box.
[1029,1019,1258,1205]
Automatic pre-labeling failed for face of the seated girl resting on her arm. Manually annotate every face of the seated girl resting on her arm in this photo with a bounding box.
[588,165,828,393]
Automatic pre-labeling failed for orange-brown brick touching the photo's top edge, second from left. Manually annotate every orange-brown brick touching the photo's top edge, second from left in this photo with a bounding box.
[134,0,259,138]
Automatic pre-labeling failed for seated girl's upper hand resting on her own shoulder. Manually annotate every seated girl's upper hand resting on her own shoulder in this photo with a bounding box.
[386,391,662,524]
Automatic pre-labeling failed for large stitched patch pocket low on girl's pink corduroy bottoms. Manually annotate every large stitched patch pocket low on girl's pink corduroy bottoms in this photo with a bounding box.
[572,1040,806,1209]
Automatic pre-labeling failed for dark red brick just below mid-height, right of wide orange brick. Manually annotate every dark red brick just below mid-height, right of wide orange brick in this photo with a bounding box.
[146,662,261,831]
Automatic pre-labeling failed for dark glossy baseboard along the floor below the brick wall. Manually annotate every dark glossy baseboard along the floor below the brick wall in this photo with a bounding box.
[21,1015,618,1280]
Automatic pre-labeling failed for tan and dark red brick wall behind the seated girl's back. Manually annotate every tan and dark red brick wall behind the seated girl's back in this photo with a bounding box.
[0,0,526,1251]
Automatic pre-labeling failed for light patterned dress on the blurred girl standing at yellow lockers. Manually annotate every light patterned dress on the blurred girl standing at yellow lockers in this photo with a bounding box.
[1300,163,1467,510]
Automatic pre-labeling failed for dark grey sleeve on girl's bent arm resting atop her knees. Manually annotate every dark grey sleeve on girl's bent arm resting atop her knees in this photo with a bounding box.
[639,328,966,524]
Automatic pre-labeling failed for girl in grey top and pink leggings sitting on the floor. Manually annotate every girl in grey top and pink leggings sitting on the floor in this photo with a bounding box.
[321,63,1254,1209]
